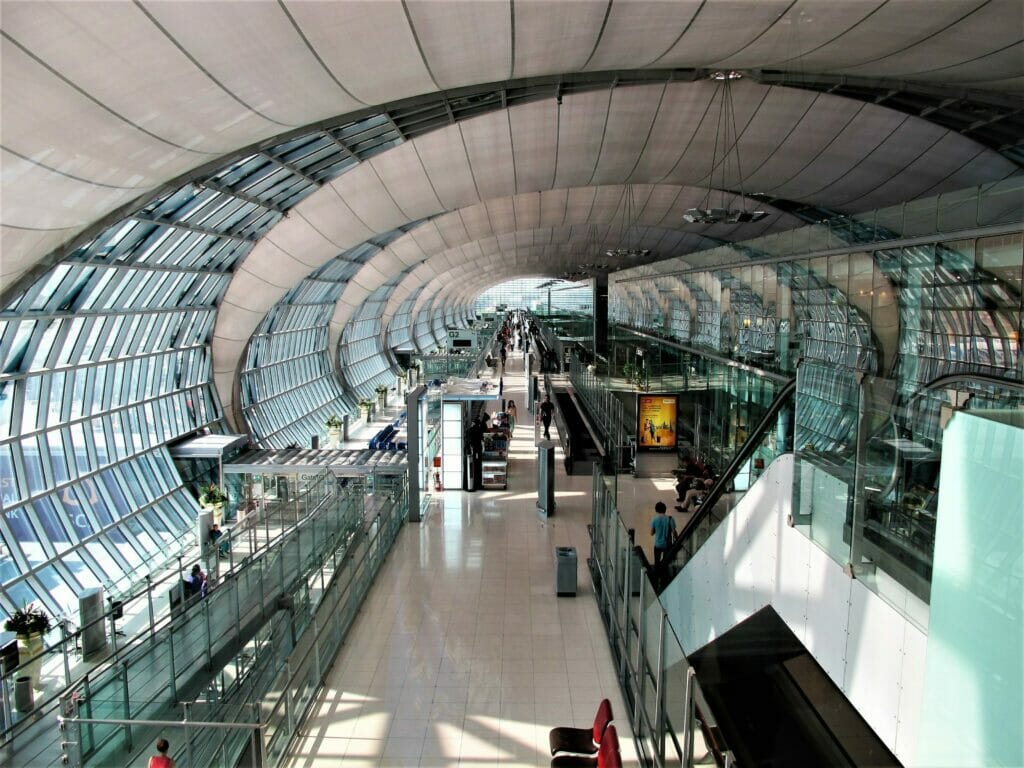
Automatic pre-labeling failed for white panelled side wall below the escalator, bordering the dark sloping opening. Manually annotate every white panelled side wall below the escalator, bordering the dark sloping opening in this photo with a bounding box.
[662,456,927,763]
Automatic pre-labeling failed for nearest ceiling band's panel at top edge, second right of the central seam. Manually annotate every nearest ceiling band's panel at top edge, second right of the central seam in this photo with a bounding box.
[587,0,701,71]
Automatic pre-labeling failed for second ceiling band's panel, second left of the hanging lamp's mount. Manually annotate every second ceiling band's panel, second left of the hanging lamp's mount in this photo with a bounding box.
[590,84,667,184]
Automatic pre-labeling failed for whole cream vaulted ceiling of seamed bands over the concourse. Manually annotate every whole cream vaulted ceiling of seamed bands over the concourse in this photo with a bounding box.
[0,0,1024,421]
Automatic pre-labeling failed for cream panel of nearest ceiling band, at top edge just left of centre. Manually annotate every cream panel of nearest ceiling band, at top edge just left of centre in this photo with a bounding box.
[406,0,512,89]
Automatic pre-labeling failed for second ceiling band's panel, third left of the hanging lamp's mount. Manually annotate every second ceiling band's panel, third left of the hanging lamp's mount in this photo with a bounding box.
[555,90,611,186]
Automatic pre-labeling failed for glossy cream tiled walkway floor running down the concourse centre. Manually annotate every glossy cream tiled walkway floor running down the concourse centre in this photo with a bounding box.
[287,357,671,768]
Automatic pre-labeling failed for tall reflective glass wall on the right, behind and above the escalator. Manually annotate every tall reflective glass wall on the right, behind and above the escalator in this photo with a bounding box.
[611,230,1024,606]
